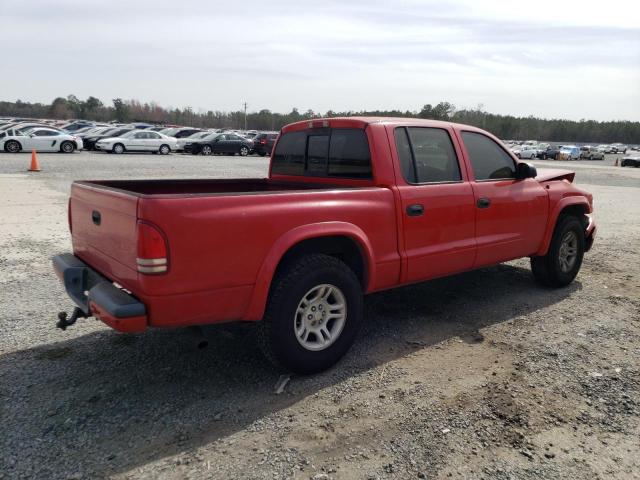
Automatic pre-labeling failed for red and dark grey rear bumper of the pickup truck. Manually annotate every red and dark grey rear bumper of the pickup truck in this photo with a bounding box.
[53,253,147,333]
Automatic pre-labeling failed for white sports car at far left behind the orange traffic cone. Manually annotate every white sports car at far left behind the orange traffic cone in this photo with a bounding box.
[0,127,82,153]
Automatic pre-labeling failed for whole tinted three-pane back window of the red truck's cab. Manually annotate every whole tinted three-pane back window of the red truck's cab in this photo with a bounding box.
[271,128,373,179]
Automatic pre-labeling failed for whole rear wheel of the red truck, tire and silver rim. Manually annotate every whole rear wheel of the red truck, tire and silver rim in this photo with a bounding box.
[258,254,363,374]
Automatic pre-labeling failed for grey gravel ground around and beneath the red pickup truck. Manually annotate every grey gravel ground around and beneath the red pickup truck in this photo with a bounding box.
[0,153,640,480]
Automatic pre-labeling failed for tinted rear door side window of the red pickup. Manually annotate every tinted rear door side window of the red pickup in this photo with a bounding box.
[395,127,462,183]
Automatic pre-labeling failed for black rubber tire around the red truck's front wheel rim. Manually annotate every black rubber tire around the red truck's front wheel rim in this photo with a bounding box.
[531,215,585,288]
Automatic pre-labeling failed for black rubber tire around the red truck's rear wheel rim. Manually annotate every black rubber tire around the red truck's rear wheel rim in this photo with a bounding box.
[258,254,363,374]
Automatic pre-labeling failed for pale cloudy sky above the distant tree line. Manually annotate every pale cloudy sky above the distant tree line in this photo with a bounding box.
[0,0,640,121]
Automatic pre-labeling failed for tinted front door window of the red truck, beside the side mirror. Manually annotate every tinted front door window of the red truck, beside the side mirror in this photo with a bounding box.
[462,132,516,180]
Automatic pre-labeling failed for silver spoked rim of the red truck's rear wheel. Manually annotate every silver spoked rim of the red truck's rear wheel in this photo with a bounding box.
[293,283,347,352]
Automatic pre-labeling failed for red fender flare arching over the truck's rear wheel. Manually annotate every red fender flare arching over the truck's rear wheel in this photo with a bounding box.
[242,222,375,321]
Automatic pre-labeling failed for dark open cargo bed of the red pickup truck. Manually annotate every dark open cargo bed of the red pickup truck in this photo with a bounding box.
[76,178,353,196]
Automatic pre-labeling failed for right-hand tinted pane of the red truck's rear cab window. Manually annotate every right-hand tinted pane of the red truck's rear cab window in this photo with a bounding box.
[327,128,371,178]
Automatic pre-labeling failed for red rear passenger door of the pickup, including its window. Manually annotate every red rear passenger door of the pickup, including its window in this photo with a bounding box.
[393,127,476,282]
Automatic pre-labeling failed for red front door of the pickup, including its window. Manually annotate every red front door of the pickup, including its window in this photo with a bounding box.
[460,130,548,267]
